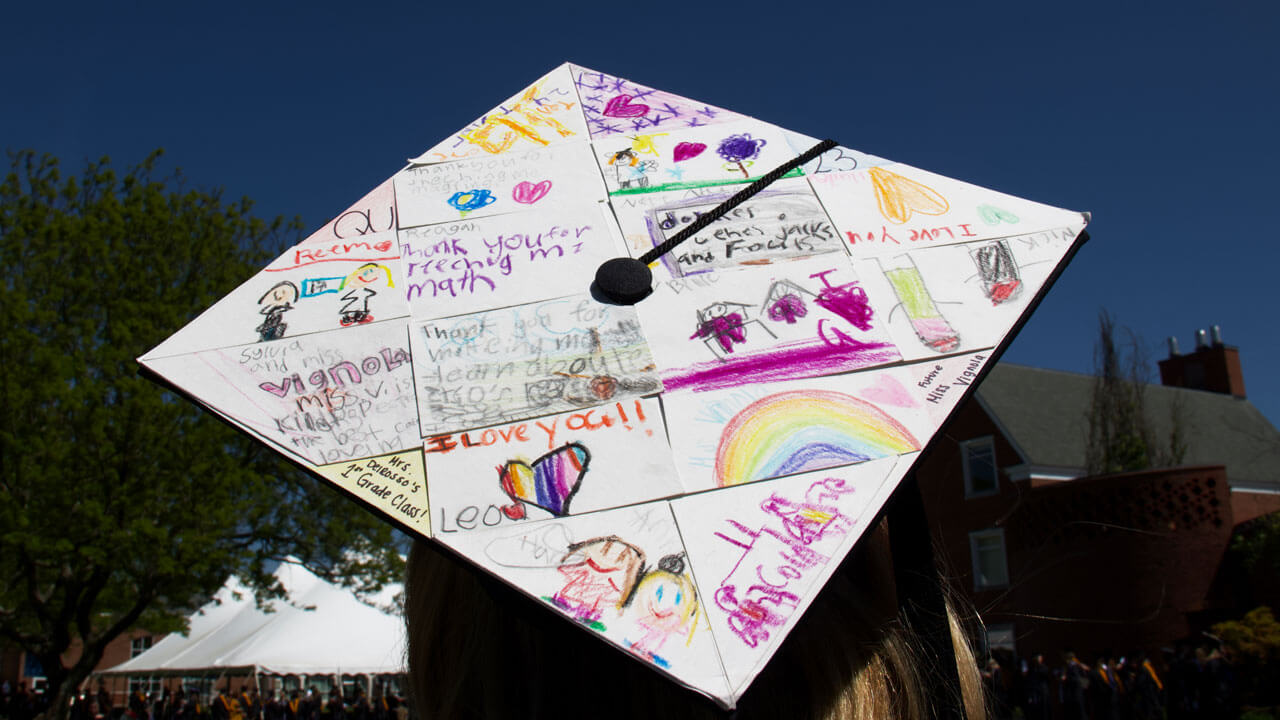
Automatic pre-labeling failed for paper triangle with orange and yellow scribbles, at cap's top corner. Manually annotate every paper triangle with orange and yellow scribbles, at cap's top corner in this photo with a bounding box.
[410,63,588,165]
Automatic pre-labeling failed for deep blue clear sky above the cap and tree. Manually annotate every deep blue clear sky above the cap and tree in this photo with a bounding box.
[10,1,1280,421]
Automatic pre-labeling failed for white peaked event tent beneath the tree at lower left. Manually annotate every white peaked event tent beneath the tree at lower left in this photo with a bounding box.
[105,562,404,675]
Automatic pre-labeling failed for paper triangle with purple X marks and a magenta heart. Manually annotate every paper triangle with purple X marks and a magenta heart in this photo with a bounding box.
[570,65,745,138]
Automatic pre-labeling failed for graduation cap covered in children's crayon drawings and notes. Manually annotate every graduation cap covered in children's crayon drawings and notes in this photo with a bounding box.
[140,64,1088,707]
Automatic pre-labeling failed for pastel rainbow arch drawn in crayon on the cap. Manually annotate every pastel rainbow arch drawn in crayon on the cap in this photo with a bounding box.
[716,389,920,487]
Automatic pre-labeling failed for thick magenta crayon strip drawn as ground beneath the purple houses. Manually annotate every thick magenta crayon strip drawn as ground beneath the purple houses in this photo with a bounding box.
[662,336,902,392]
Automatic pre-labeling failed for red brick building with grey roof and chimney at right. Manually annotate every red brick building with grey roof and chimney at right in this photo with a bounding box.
[920,333,1280,657]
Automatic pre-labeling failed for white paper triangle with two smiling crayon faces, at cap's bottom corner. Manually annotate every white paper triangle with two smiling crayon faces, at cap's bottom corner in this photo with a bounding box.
[435,502,732,706]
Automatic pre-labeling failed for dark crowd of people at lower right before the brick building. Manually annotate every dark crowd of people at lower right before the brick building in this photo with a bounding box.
[982,646,1240,720]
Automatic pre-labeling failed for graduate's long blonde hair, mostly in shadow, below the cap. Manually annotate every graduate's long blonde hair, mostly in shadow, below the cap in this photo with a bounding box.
[404,515,986,720]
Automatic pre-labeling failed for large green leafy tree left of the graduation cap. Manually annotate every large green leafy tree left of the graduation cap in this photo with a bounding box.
[0,151,399,716]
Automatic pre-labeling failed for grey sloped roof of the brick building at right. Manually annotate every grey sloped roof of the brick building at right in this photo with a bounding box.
[978,363,1280,491]
